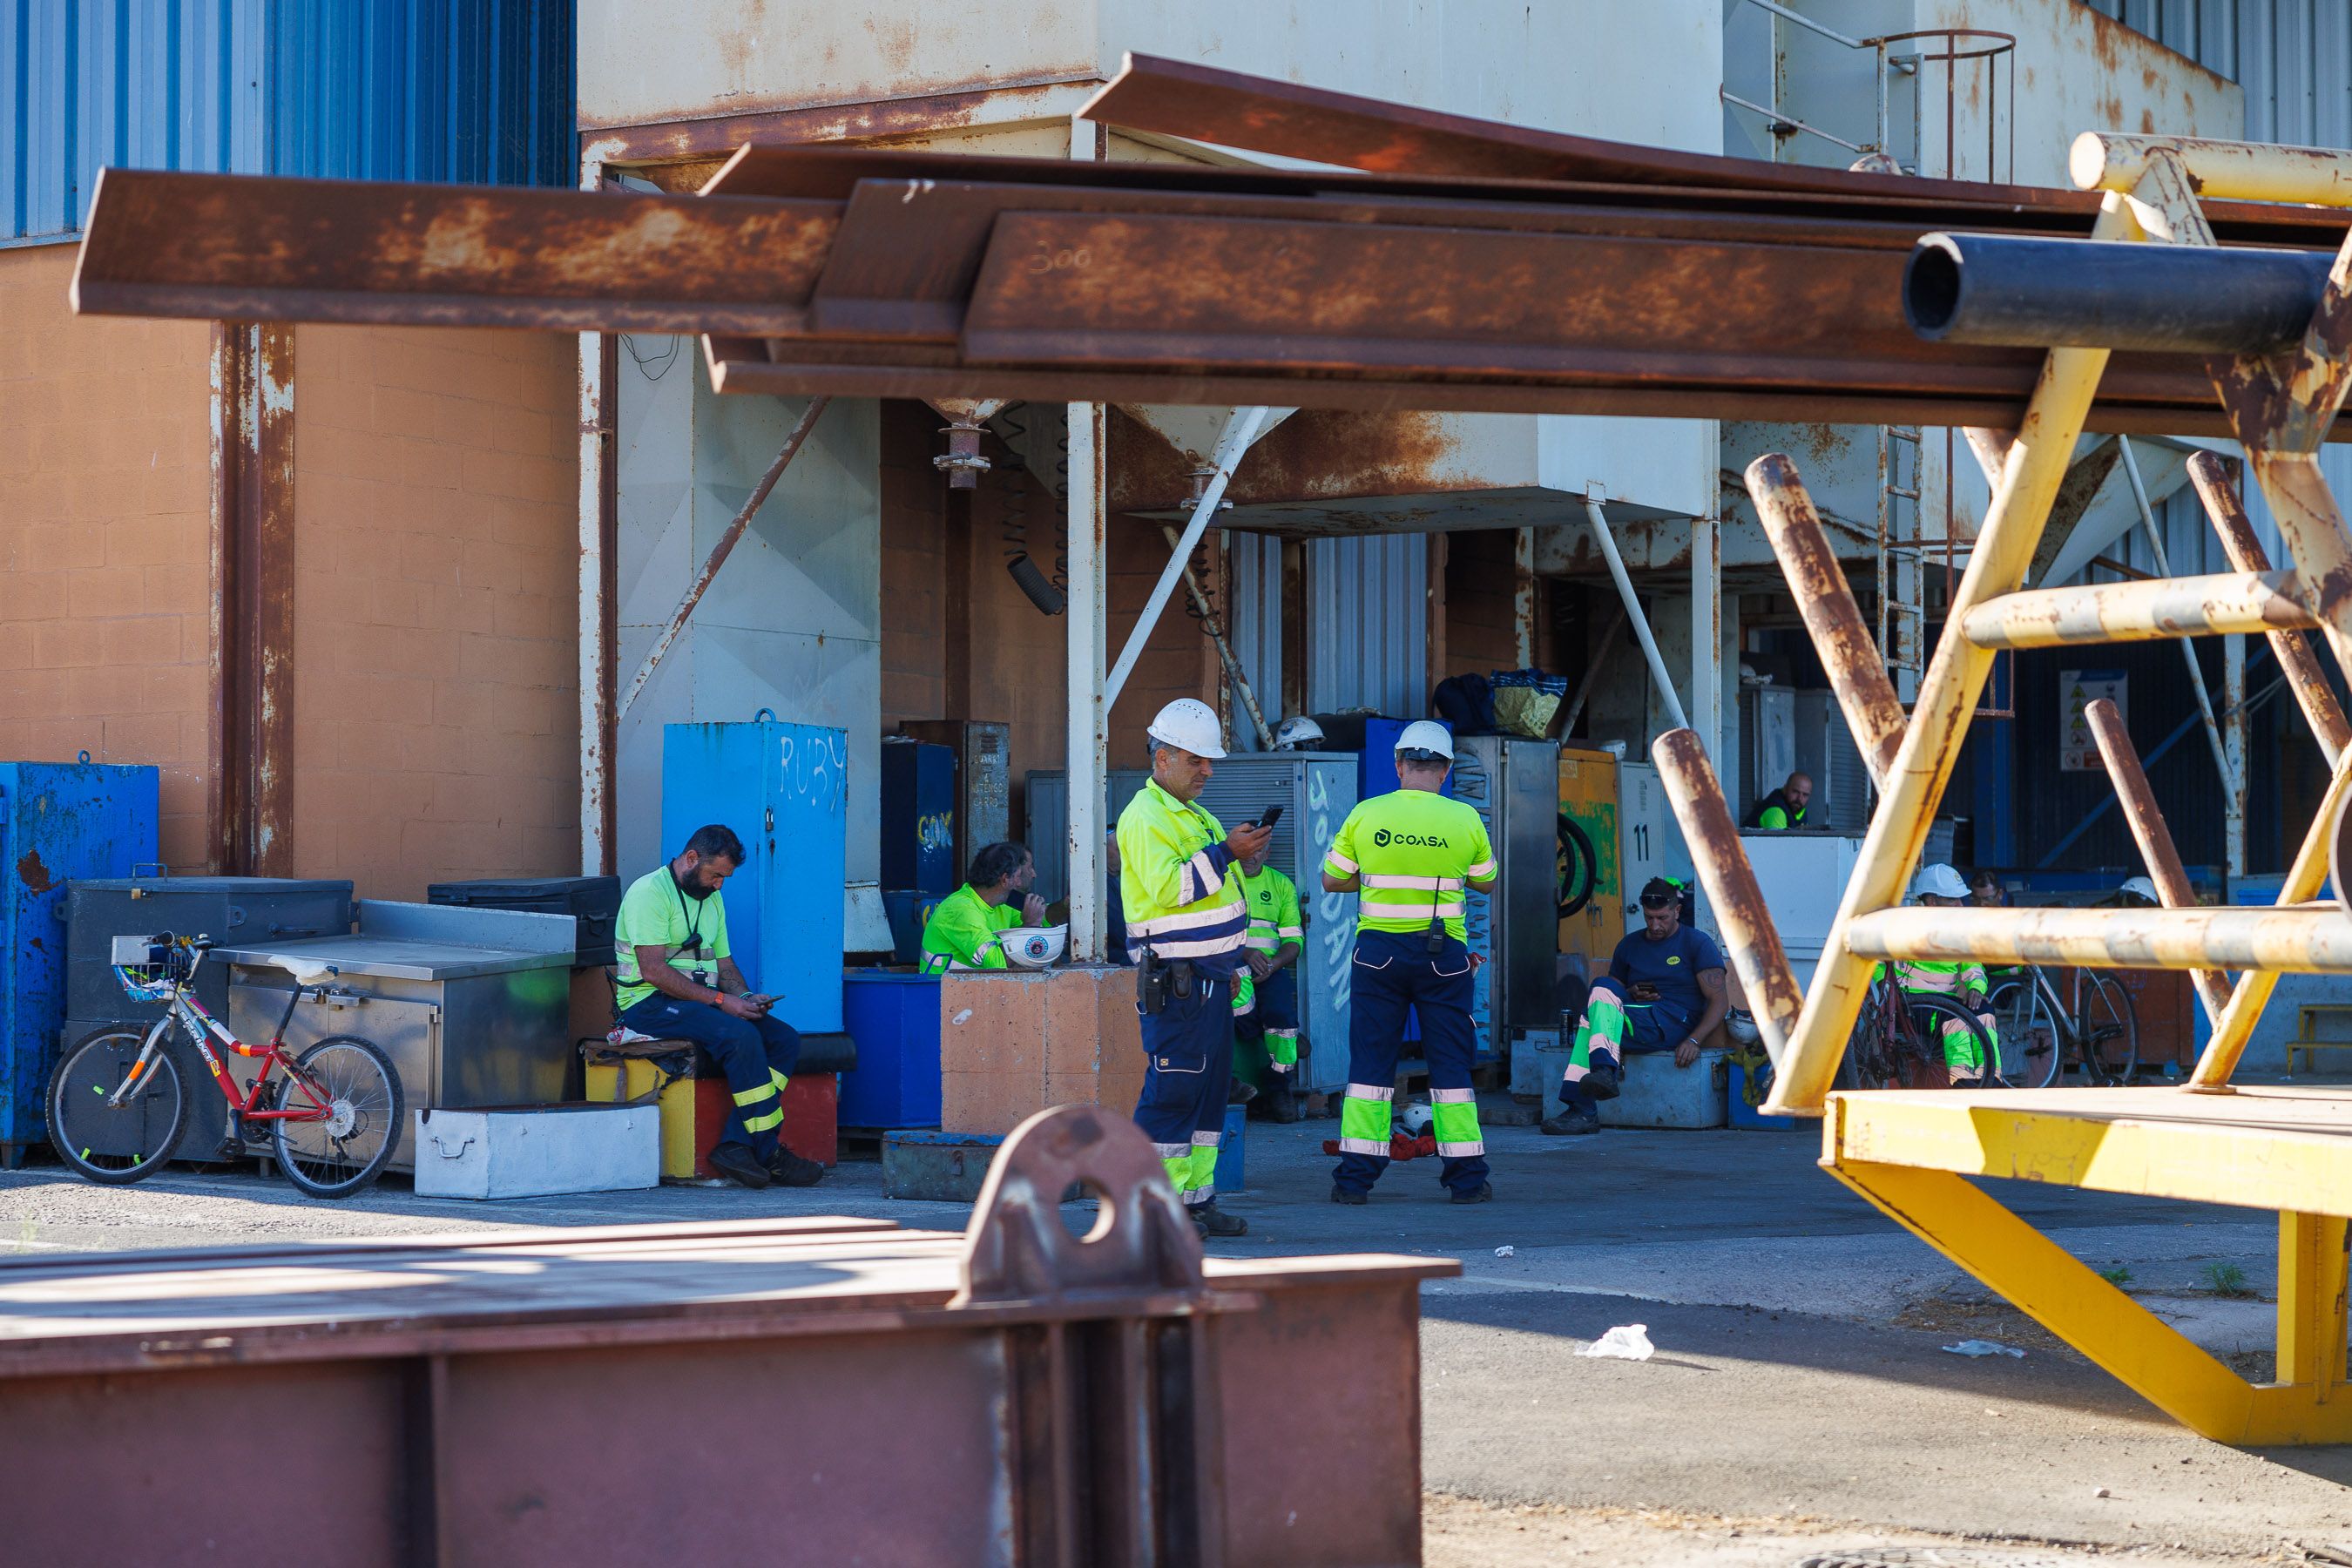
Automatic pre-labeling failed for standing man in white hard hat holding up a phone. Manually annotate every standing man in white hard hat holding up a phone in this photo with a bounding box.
[1119,698,1274,1236]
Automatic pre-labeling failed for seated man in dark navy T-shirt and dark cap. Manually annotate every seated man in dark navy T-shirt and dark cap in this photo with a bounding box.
[1543,877,1731,1135]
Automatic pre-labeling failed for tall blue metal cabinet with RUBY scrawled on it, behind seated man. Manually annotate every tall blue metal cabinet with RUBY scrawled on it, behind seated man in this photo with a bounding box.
[661,720,849,1034]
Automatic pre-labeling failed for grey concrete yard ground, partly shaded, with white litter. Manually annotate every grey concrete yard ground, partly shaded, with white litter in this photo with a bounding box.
[0,1121,2352,1565]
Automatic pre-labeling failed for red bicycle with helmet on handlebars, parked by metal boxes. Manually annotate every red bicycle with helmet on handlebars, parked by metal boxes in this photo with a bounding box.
[47,931,402,1199]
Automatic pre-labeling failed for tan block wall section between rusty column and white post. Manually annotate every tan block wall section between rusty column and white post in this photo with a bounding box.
[294,327,578,898]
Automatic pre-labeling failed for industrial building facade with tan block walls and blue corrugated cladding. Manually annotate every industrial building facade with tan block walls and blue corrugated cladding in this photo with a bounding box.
[0,0,2352,959]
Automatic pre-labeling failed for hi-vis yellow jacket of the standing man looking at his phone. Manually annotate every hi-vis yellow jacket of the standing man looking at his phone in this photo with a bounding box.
[1119,781,1247,976]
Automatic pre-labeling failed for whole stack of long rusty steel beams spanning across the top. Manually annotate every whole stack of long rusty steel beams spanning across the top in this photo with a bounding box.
[59,58,2342,435]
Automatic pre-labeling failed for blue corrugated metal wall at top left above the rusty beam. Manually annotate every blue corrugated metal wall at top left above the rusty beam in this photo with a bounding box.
[0,0,577,242]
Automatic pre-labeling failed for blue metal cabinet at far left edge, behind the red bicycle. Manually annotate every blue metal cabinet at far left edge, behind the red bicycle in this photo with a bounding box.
[0,761,157,1166]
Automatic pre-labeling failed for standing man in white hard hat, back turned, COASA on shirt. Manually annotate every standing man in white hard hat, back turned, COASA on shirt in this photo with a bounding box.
[1321,720,1498,1204]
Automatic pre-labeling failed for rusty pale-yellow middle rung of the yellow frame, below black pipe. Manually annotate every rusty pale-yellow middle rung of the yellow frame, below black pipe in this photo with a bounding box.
[1959,571,2319,649]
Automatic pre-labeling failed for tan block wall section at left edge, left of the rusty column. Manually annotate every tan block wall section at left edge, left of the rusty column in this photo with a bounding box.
[0,245,212,870]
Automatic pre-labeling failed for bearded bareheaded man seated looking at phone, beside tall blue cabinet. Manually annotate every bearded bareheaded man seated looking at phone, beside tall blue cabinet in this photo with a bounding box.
[614,823,826,1187]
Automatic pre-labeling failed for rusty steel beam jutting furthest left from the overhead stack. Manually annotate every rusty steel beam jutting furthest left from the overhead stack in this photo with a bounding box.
[73,169,840,332]
